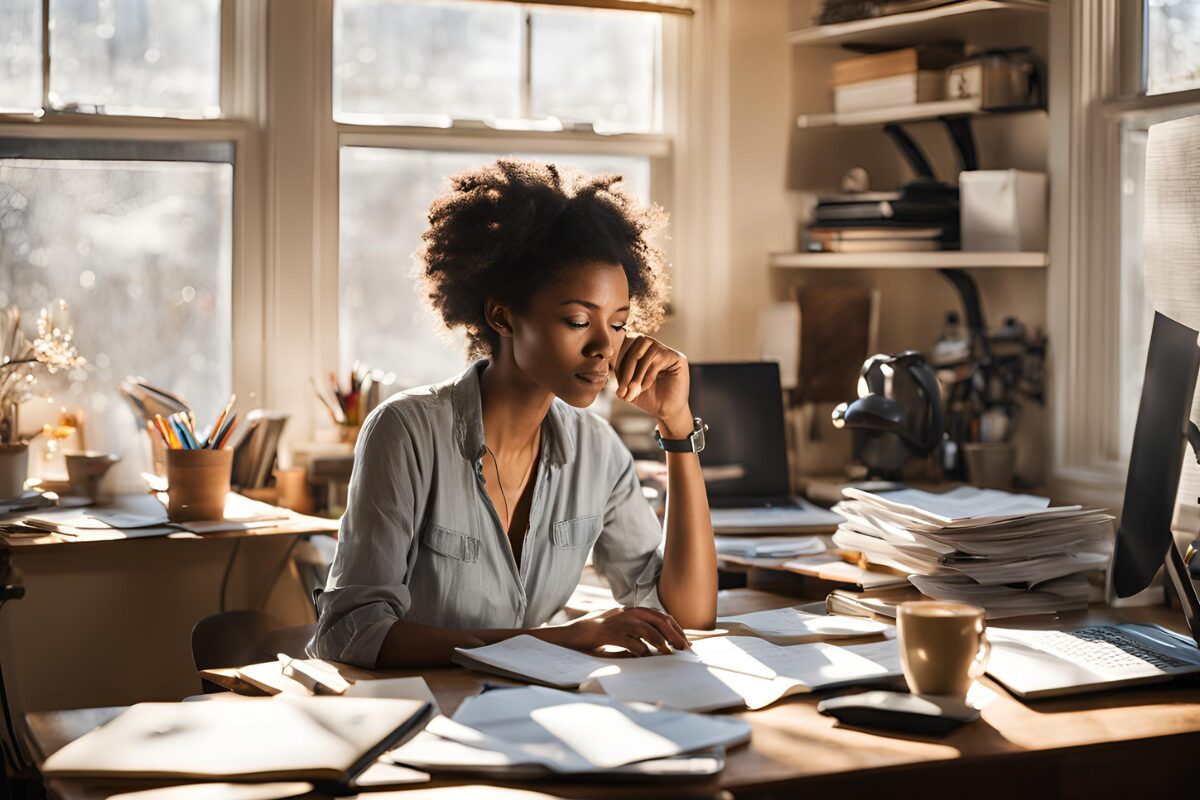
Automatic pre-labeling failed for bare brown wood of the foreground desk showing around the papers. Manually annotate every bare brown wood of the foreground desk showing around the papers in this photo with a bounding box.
[29,589,1200,800]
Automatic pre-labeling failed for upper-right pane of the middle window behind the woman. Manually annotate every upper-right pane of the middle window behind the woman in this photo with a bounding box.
[530,8,661,132]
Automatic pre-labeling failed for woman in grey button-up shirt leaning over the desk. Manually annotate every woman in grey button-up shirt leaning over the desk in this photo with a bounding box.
[308,160,716,668]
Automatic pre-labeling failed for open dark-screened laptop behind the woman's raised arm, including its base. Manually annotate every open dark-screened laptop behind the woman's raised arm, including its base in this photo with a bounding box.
[688,361,842,534]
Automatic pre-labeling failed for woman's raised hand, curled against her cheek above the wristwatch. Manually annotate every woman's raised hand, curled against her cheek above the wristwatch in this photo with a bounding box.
[613,335,692,435]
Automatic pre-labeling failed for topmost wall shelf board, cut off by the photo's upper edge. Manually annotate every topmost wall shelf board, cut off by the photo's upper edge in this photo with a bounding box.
[787,0,1050,47]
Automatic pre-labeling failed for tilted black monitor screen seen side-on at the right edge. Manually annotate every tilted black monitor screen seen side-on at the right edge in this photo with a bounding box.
[1112,313,1200,644]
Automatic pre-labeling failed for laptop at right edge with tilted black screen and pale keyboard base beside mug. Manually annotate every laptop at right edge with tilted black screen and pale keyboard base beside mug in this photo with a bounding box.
[988,314,1200,699]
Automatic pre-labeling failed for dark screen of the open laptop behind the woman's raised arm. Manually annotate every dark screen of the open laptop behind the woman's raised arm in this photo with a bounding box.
[689,361,790,498]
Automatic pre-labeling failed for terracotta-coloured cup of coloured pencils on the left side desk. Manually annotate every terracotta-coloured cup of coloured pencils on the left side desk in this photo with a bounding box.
[155,397,238,522]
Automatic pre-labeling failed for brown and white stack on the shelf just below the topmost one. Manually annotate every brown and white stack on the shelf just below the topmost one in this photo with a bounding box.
[830,46,962,113]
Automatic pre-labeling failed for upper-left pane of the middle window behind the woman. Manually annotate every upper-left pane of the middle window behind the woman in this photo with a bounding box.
[334,0,522,124]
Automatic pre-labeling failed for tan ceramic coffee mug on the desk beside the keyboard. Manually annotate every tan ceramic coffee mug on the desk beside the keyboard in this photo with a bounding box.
[896,600,991,699]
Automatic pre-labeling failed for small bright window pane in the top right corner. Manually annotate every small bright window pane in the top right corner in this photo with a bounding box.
[1146,0,1200,95]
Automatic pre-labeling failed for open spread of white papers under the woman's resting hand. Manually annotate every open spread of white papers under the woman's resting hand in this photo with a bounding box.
[454,636,900,711]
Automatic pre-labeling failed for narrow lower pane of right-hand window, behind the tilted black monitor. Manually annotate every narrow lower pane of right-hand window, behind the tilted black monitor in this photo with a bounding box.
[1117,122,1154,459]
